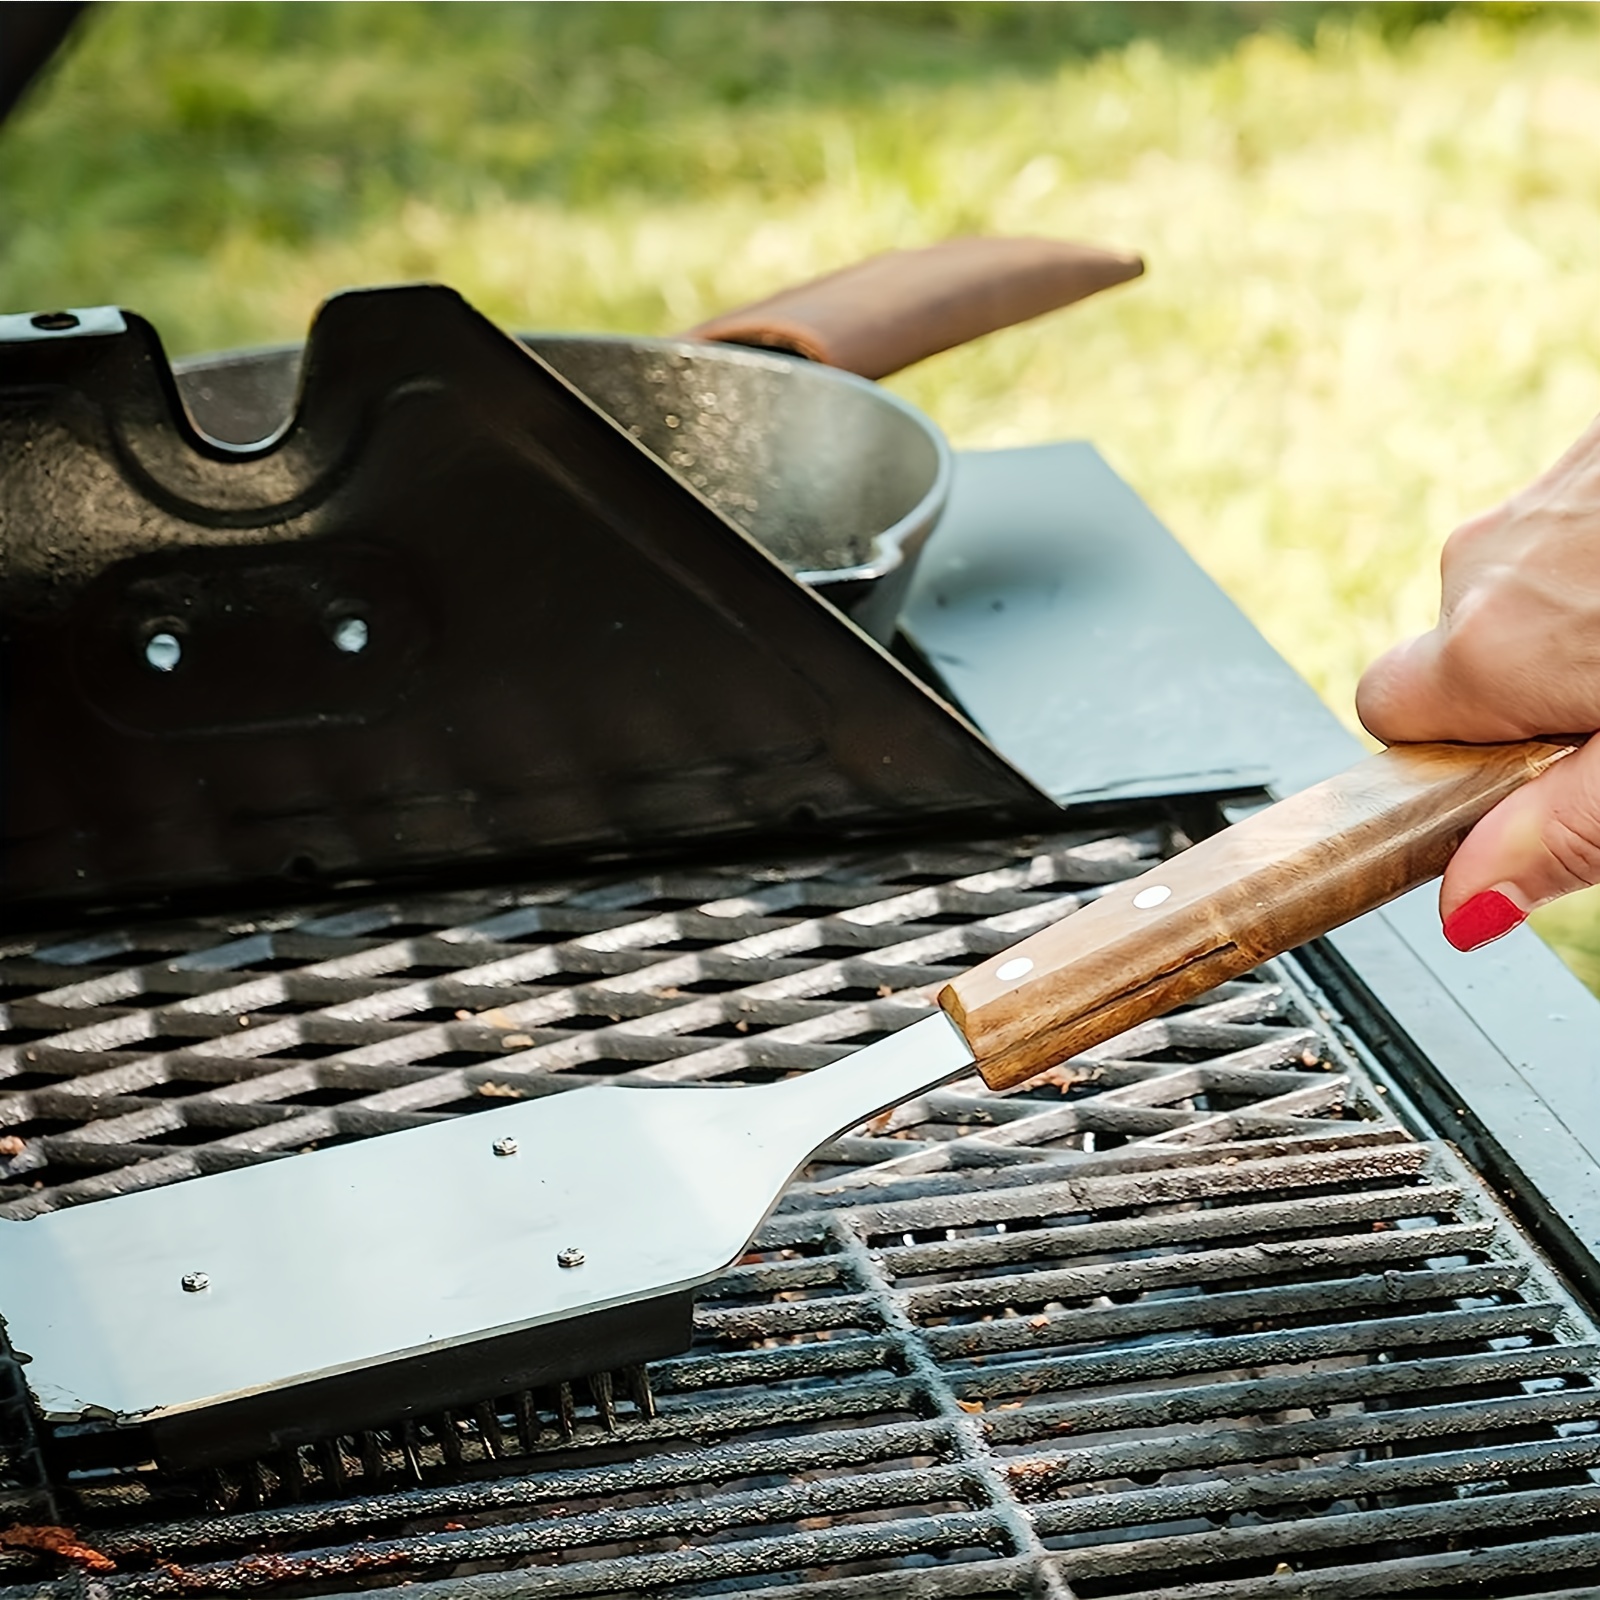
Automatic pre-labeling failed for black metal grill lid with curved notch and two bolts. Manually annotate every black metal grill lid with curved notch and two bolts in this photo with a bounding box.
[0,288,1059,915]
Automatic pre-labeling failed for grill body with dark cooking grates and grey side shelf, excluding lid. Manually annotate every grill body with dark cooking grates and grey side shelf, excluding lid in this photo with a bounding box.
[0,446,1600,1600]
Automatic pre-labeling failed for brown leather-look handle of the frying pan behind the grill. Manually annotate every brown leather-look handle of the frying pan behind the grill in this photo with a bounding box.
[683,238,1144,378]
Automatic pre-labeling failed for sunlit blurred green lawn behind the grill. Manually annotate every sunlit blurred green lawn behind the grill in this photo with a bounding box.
[9,0,1600,989]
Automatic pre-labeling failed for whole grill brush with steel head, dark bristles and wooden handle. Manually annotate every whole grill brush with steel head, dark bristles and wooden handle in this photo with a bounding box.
[0,742,1570,1482]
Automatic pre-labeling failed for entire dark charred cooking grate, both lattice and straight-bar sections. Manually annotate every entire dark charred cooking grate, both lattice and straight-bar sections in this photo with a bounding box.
[0,832,1600,1600]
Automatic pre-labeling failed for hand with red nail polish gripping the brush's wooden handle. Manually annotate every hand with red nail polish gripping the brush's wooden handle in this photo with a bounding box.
[1355,418,1600,950]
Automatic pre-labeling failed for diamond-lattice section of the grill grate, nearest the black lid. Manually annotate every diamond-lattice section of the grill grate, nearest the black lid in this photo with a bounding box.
[0,829,1324,1219]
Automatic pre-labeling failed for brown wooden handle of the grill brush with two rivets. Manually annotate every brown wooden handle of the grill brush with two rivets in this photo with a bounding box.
[939,741,1573,1090]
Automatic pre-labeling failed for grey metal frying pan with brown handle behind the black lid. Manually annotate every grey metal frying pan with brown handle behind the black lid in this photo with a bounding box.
[174,238,1142,642]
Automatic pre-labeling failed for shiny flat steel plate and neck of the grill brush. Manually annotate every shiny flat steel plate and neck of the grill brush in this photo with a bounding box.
[0,1013,973,1440]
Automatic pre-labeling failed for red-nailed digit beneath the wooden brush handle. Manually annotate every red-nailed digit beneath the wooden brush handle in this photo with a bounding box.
[1438,739,1600,950]
